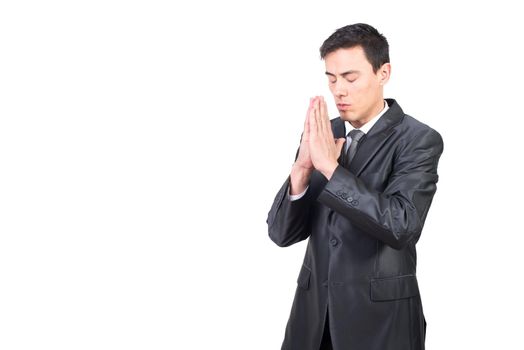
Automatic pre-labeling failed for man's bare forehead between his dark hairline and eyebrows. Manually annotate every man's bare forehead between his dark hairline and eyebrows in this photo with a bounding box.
[324,46,373,74]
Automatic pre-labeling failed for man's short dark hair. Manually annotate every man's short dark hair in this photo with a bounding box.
[320,23,389,73]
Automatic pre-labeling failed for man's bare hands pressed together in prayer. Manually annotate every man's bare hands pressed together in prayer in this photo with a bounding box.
[295,96,346,180]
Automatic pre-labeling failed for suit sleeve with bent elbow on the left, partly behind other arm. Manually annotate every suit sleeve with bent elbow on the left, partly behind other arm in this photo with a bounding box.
[266,135,313,247]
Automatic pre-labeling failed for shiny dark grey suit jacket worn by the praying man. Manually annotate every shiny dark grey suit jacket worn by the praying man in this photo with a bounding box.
[267,99,443,350]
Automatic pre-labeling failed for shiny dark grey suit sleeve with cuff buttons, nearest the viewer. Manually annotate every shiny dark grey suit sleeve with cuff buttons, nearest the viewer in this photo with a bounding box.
[318,129,443,249]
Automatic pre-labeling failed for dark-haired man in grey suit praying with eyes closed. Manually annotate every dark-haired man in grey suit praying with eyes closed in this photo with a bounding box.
[267,24,443,350]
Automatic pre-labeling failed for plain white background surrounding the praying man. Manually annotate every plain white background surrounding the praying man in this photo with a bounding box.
[0,1,524,350]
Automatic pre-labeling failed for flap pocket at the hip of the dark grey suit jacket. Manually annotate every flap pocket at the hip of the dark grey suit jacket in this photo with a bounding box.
[370,275,419,301]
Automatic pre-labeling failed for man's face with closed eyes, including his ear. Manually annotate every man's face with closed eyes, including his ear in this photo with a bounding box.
[324,46,390,128]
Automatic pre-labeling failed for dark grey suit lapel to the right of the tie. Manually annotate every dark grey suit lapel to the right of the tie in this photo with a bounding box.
[348,99,404,176]
